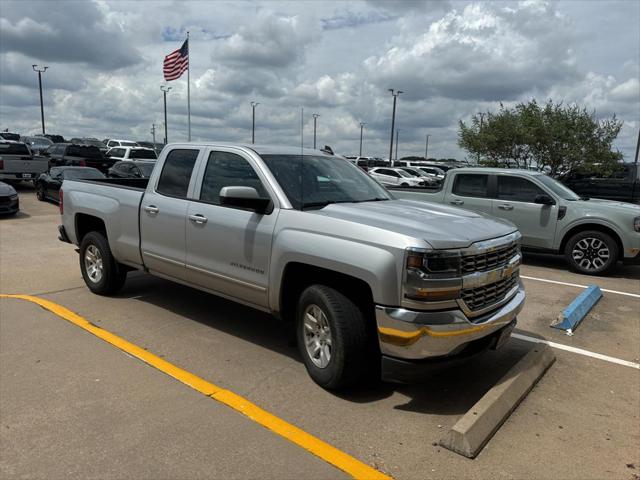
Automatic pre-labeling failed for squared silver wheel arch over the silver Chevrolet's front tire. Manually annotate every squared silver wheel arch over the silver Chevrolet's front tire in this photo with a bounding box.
[280,262,375,321]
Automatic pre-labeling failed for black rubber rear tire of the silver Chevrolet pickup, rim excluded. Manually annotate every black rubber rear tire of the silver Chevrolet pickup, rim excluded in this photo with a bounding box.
[80,232,127,295]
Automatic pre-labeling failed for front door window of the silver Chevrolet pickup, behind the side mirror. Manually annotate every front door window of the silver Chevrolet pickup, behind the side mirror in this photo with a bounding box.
[200,152,267,205]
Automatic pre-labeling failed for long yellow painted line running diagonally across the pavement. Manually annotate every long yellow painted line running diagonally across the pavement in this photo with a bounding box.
[0,294,391,480]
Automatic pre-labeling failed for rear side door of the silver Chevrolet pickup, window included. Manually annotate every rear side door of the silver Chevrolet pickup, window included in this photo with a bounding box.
[140,148,200,280]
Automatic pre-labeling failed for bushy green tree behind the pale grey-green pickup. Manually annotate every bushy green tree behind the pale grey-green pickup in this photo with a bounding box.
[458,100,622,173]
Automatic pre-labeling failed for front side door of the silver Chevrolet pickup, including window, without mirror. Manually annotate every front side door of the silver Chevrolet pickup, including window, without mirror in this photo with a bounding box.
[186,147,278,307]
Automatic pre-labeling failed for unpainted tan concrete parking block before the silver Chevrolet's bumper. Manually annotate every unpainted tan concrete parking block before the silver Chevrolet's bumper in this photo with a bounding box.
[439,346,556,458]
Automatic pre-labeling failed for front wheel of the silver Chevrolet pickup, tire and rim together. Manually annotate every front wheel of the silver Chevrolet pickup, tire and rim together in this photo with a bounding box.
[296,285,369,389]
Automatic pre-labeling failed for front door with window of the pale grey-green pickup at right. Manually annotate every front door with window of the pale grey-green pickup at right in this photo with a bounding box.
[493,174,558,248]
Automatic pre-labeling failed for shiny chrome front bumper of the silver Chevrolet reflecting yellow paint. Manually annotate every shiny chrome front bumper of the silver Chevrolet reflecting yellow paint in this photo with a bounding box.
[376,280,525,360]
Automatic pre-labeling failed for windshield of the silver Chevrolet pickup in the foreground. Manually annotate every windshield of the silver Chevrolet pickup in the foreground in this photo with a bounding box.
[261,155,393,210]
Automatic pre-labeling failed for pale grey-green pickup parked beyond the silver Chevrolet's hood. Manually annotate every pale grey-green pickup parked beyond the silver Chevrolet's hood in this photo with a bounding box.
[393,168,640,275]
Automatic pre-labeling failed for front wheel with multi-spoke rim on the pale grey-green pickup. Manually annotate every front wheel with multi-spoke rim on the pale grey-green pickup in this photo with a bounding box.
[564,230,620,275]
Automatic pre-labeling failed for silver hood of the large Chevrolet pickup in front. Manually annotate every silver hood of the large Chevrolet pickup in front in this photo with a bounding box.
[313,200,517,249]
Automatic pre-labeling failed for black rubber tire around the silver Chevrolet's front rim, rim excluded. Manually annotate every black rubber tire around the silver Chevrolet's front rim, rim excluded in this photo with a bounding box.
[296,285,368,390]
